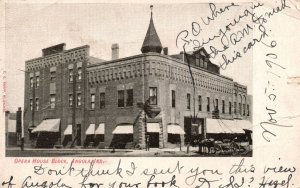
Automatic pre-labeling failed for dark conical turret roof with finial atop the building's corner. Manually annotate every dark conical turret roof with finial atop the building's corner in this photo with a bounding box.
[141,7,162,53]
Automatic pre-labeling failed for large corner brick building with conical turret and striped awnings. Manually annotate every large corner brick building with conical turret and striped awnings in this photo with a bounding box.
[24,7,252,148]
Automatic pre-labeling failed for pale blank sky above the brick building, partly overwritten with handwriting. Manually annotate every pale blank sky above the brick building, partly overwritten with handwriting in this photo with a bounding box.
[5,3,253,111]
